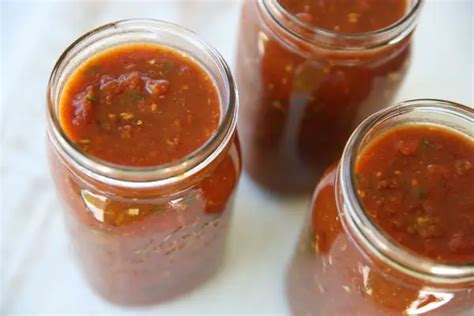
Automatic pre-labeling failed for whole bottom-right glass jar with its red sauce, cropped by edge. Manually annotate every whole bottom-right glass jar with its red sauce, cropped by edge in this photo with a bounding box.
[287,100,474,315]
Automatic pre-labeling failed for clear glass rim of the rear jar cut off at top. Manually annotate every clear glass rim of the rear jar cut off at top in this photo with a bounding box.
[257,0,424,51]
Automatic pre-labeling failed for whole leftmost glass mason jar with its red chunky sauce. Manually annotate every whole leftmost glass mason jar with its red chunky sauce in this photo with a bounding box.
[48,20,241,304]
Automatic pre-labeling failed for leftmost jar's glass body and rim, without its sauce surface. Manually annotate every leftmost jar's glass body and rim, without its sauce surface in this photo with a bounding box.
[47,20,241,304]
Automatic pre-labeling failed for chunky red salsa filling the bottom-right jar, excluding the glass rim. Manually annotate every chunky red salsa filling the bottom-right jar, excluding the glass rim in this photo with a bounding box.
[288,121,474,316]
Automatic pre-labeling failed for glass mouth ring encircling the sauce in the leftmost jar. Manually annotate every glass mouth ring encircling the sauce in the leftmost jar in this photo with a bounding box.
[48,19,237,182]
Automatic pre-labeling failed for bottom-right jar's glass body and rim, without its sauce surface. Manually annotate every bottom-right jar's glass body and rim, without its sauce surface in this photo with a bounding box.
[287,100,474,315]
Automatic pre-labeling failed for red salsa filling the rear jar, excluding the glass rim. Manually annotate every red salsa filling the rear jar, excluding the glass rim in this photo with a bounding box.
[236,0,411,194]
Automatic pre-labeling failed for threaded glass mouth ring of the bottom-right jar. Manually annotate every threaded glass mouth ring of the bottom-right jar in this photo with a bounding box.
[336,99,474,284]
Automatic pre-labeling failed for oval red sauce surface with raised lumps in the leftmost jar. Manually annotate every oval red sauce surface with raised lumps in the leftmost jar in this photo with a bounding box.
[59,44,220,166]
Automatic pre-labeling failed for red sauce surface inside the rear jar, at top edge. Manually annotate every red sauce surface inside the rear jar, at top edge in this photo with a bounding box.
[278,0,407,33]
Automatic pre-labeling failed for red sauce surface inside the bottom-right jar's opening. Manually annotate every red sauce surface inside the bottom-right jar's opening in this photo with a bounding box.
[355,125,474,264]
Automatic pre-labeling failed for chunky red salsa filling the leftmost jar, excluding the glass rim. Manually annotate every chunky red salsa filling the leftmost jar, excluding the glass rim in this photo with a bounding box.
[49,38,241,305]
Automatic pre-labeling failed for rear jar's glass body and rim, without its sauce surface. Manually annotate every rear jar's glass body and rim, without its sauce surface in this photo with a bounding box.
[236,0,422,194]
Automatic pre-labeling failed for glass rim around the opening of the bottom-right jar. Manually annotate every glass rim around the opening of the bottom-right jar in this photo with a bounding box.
[338,100,474,283]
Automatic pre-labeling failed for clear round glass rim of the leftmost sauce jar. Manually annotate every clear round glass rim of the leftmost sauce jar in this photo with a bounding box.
[47,19,239,188]
